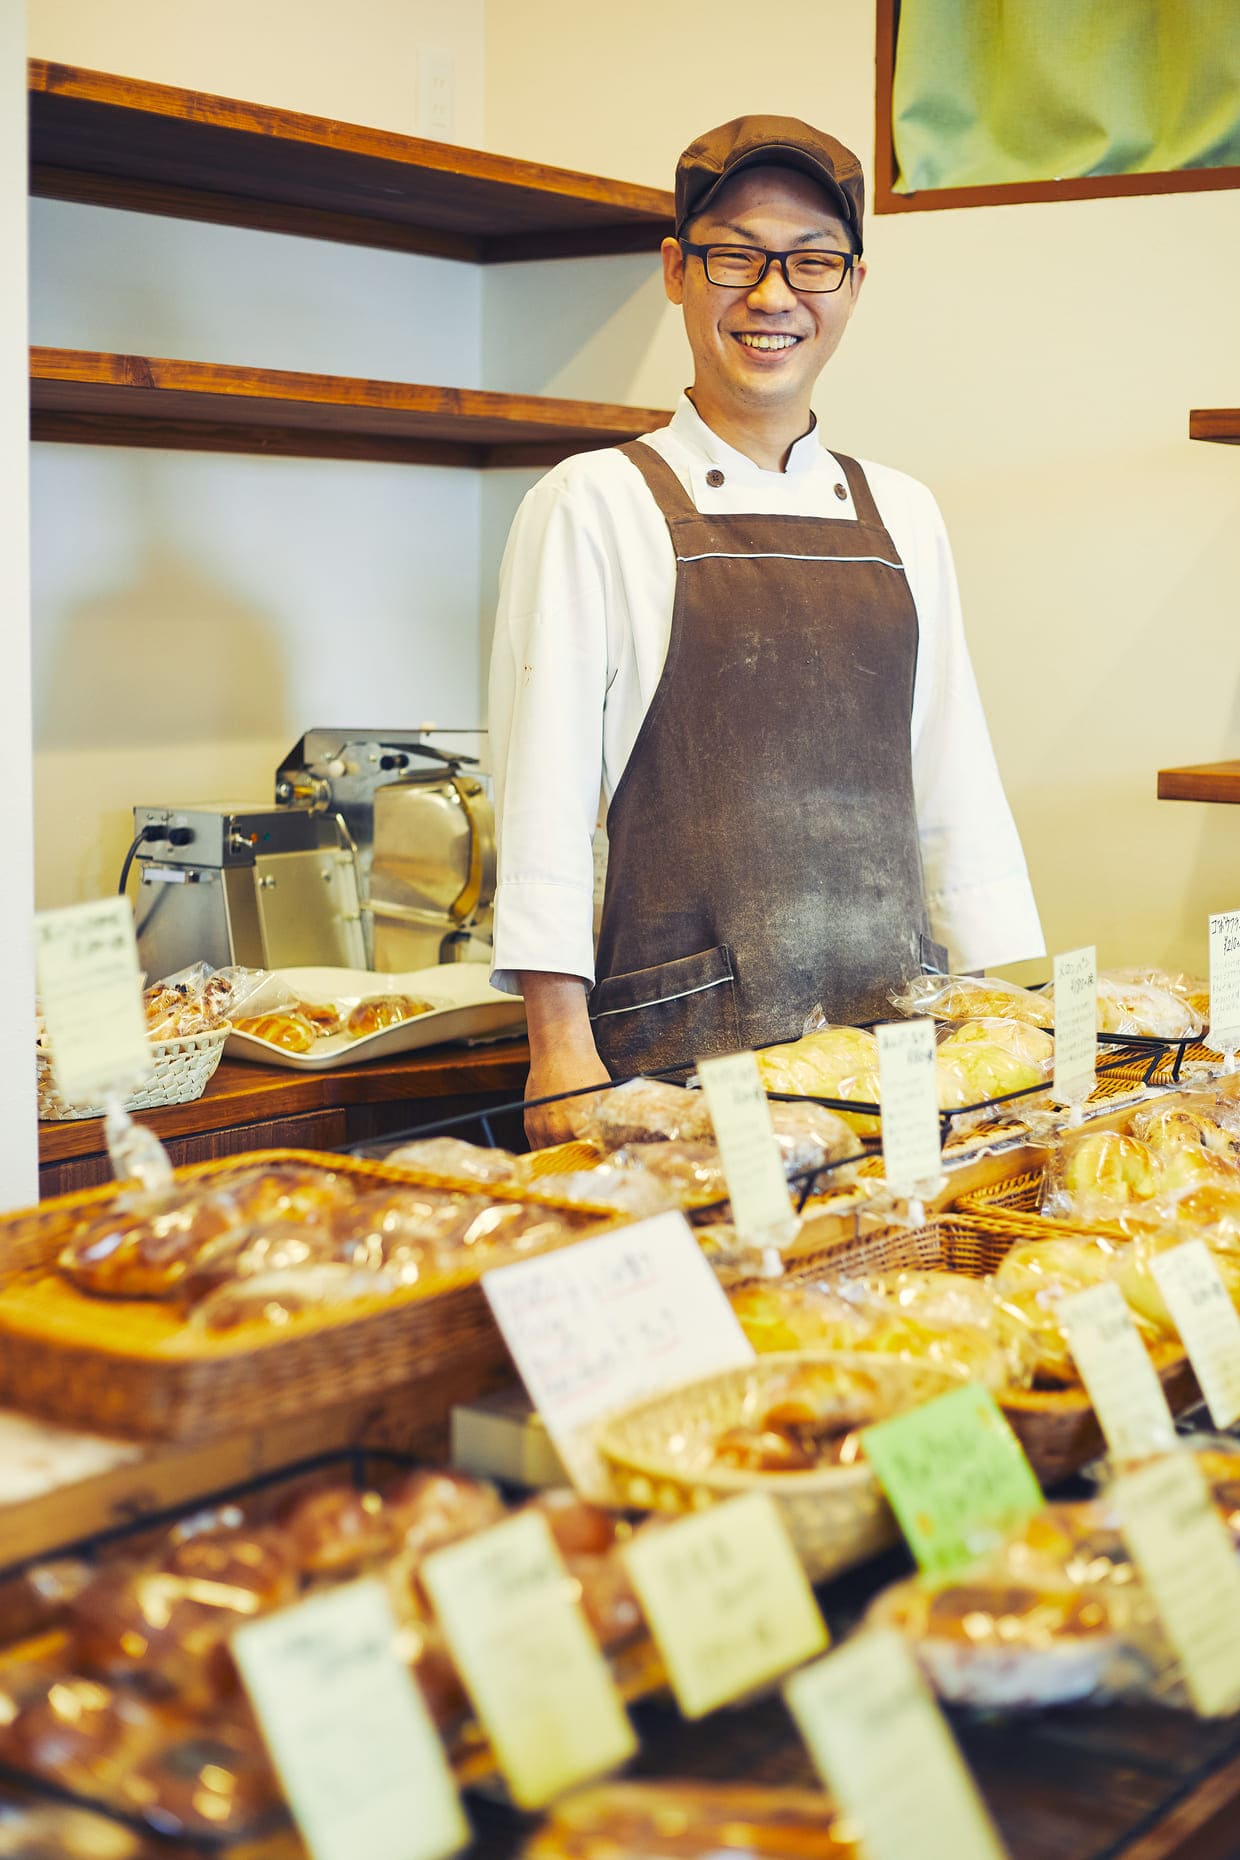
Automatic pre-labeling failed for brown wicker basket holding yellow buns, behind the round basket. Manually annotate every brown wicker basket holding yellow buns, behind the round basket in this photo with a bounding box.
[792,1211,1201,1486]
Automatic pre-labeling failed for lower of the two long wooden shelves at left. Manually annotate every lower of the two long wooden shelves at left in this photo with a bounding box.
[30,348,671,469]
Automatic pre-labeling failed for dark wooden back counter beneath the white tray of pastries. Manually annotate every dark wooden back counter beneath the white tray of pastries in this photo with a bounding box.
[39,1040,530,1196]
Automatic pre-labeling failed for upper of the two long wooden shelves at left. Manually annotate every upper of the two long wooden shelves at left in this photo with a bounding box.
[28,60,673,264]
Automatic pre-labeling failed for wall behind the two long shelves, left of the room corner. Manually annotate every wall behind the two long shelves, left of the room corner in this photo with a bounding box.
[30,0,483,906]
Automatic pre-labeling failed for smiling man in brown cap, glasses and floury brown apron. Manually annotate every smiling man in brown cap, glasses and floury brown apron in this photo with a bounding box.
[491,117,1043,1142]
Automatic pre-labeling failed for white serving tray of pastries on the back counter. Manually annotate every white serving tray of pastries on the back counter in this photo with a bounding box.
[223,962,526,1071]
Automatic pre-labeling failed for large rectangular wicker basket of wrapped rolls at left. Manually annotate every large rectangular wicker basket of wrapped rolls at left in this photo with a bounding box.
[0,1149,606,1440]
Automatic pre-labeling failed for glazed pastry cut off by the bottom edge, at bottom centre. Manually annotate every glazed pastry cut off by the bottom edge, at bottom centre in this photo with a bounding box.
[522,1782,861,1860]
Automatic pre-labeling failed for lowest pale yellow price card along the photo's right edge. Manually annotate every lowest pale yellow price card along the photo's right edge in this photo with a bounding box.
[1110,1449,1240,1717]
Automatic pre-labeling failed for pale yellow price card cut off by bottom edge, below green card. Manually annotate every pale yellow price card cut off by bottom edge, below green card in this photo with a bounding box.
[785,1628,1004,1860]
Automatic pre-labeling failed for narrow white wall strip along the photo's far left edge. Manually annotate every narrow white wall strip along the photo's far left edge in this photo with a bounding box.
[0,7,37,1209]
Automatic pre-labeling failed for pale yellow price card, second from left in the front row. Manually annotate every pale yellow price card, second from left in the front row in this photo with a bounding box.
[422,1512,638,1808]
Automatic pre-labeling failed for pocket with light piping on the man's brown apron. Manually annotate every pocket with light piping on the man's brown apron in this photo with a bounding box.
[589,943,740,1079]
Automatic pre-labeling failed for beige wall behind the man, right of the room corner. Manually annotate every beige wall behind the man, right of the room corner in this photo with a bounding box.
[483,0,1240,989]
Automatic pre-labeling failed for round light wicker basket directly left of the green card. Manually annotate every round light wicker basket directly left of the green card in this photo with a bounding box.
[595,1352,957,1583]
